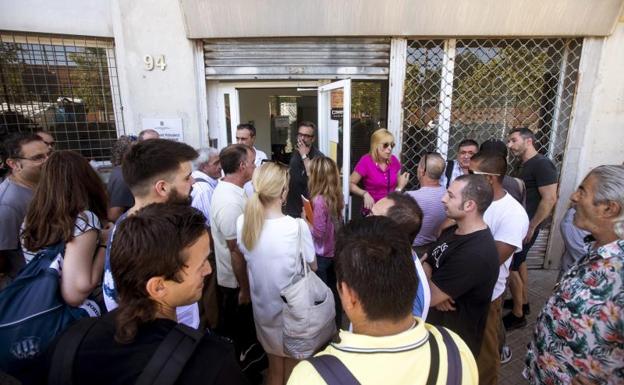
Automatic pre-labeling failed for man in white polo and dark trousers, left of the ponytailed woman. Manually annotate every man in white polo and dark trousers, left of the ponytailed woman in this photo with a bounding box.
[210,144,256,357]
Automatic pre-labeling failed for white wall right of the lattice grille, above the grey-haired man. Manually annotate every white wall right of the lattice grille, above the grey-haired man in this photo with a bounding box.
[546,17,624,268]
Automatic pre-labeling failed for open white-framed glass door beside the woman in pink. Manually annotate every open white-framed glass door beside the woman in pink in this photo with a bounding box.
[318,79,351,221]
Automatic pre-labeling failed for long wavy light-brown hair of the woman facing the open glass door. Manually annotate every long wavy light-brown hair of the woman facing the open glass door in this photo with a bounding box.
[308,156,344,220]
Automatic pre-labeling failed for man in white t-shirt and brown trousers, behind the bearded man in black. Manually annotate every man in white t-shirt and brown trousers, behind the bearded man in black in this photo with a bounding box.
[469,151,529,385]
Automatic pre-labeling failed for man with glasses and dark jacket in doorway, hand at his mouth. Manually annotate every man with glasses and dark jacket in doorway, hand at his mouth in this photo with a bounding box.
[284,121,323,218]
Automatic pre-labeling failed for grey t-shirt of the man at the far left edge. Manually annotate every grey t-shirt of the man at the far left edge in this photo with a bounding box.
[0,178,33,276]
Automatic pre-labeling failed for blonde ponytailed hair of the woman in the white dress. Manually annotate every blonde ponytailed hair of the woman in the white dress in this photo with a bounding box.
[242,162,289,250]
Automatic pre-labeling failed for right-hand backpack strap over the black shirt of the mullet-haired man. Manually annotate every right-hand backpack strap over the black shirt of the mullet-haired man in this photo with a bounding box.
[135,324,204,385]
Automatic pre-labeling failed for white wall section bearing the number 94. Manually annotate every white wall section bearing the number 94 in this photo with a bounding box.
[112,0,208,147]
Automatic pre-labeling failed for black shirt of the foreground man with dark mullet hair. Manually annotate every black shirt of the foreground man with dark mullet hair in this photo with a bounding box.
[55,311,247,385]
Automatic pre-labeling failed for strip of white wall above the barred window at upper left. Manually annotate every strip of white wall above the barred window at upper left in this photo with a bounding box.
[0,0,113,37]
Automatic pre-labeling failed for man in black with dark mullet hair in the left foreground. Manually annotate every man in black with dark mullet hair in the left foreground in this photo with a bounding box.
[51,203,245,385]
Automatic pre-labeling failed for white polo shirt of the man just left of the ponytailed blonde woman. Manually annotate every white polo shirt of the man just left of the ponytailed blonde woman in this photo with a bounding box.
[210,180,247,288]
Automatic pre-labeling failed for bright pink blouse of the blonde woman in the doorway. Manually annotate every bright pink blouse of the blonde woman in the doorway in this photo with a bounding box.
[354,154,401,202]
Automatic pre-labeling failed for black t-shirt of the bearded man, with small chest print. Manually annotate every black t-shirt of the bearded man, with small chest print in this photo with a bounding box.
[427,226,499,357]
